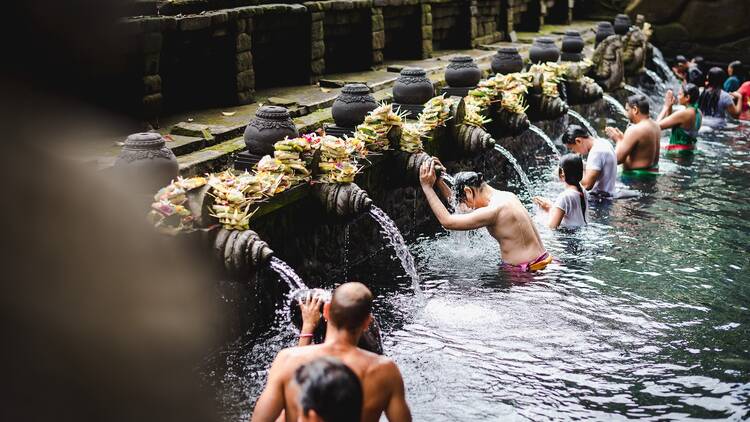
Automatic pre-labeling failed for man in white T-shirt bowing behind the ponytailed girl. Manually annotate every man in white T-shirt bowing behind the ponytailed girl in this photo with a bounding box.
[562,125,617,198]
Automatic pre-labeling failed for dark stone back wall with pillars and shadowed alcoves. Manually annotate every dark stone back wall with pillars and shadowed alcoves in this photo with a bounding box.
[116,0,574,120]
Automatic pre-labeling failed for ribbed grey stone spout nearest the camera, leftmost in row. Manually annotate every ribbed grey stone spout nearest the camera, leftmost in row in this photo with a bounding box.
[213,228,273,278]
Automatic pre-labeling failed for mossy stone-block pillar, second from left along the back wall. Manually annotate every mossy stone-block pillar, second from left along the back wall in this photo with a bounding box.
[230,15,255,104]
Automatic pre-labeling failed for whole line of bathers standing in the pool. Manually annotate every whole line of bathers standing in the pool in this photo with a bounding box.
[252,56,750,422]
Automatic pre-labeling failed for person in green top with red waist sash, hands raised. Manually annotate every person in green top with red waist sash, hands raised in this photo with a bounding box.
[656,84,702,154]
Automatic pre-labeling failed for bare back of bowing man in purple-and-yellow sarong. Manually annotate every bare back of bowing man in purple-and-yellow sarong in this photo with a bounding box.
[487,190,545,265]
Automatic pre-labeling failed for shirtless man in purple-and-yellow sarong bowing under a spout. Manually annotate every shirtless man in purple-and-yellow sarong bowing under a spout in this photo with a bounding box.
[419,159,552,272]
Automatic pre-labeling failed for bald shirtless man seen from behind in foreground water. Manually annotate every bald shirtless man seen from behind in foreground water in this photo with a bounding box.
[252,283,411,422]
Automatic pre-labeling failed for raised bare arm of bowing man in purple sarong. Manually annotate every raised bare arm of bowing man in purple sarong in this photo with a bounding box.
[419,162,498,230]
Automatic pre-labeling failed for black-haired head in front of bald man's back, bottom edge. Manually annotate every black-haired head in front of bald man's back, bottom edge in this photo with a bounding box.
[294,357,363,422]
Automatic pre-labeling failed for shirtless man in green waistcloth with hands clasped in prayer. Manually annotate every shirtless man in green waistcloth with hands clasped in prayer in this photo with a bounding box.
[605,95,661,177]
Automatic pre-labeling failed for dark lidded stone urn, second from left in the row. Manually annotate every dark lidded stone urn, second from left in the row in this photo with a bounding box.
[244,106,299,164]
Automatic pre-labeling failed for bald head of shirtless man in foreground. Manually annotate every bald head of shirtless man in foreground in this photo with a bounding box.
[329,282,372,331]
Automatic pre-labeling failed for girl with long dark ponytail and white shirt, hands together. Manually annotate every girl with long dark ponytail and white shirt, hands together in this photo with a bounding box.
[534,154,588,229]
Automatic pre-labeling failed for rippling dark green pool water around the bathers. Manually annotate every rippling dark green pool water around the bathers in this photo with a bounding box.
[207,90,750,421]
